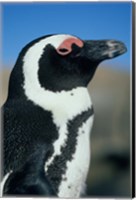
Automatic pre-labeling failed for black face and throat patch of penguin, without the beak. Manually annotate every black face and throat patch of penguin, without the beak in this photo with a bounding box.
[38,45,98,92]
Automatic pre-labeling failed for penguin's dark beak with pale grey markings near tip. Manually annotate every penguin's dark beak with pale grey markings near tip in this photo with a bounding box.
[80,40,127,62]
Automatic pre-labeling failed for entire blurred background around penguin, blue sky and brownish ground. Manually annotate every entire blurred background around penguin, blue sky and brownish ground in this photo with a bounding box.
[0,2,132,197]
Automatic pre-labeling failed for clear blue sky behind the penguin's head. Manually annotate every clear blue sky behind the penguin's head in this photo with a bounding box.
[2,2,132,70]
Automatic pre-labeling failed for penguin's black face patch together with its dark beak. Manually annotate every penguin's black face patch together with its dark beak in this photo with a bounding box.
[38,37,126,92]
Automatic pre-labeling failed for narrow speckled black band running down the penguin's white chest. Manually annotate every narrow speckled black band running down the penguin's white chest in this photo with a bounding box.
[47,108,93,191]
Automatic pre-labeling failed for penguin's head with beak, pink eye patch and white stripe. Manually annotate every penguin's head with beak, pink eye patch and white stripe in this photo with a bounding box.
[8,34,126,97]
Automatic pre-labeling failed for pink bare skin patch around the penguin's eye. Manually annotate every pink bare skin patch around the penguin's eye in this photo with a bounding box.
[57,37,83,56]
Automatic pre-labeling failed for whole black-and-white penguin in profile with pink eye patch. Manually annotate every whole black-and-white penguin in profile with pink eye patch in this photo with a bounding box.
[2,34,126,198]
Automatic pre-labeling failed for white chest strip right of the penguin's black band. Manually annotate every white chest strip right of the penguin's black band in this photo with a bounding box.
[58,118,92,198]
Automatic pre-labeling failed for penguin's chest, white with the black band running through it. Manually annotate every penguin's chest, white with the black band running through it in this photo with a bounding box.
[45,110,93,198]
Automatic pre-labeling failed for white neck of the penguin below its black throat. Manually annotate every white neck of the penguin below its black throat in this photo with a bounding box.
[24,82,92,127]
